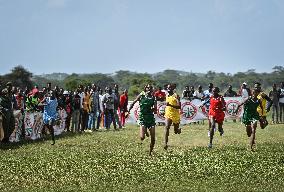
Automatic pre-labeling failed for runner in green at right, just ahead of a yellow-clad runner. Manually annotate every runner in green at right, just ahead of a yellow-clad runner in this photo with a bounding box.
[235,90,262,151]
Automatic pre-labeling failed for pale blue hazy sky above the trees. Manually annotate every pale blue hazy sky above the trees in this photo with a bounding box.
[0,0,284,74]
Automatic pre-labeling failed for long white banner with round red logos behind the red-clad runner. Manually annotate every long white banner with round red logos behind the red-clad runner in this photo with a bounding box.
[127,97,243,124]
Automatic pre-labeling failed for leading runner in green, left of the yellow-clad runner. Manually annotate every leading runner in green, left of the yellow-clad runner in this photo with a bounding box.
[129,84,156,155]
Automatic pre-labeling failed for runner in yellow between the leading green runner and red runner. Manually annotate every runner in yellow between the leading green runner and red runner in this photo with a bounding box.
[164,84,181,150]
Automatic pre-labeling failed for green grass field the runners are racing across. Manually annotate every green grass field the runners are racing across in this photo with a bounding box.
[0,122,284,191]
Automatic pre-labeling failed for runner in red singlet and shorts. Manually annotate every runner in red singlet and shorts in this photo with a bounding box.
[201,87,226,148]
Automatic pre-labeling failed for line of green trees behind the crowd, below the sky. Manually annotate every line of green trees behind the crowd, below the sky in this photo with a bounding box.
[0,66,284,97]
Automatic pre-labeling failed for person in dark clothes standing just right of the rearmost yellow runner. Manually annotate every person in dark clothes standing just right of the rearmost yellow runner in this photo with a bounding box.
[269,83,280,124]
